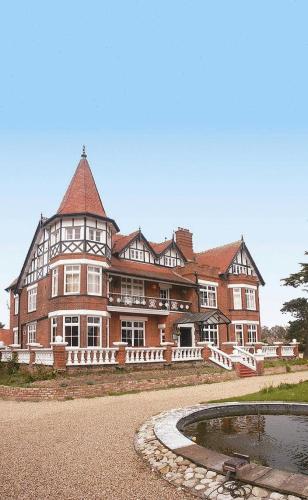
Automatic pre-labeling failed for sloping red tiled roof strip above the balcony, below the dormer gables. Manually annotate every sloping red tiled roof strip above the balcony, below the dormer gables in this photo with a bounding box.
[109,257,195,285]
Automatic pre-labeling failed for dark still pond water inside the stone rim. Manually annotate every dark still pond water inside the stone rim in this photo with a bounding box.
[183,415,308,475]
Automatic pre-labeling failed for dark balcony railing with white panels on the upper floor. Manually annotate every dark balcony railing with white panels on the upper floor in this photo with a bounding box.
[108,293,191,312]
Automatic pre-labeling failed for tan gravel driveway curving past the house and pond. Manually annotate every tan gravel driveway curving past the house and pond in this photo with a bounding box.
[0,371,308,500]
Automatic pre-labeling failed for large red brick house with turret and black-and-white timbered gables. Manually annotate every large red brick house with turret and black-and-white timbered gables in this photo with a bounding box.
[7,148,264,348]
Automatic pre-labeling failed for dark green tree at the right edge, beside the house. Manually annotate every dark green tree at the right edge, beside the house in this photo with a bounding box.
[281,252,308,358]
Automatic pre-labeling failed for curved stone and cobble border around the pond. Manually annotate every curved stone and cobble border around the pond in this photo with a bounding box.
[135,402,308,500]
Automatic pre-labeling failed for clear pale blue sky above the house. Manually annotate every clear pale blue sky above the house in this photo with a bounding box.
[0,0,308,325]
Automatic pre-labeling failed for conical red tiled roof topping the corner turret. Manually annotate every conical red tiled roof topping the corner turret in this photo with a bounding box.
[58,157,106,217]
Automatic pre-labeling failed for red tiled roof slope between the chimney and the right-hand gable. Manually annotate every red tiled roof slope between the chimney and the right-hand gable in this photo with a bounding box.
[195,240,243,273]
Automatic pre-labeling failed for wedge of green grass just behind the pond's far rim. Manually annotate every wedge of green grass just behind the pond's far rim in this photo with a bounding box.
[212,381,308,403]
